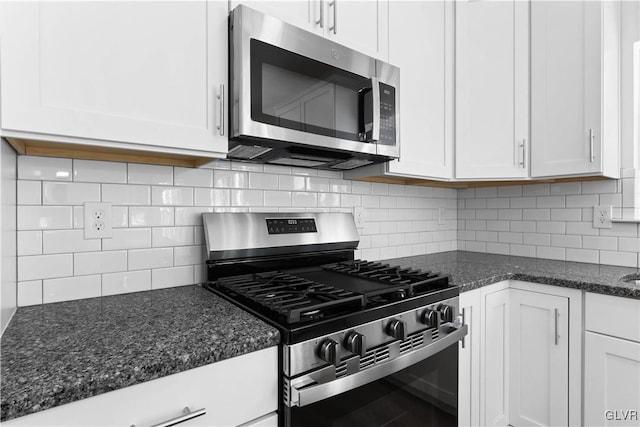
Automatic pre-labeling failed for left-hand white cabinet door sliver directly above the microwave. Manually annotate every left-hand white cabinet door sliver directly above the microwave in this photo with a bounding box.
[230,0,322,34]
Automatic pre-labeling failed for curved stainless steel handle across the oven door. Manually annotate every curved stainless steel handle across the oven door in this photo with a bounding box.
[291,325,468,407]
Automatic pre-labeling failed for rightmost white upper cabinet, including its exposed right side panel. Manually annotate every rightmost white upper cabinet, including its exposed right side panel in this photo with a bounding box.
[531,1,620,178]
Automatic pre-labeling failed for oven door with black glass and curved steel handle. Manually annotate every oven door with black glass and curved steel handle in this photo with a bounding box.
[281,326,467,427]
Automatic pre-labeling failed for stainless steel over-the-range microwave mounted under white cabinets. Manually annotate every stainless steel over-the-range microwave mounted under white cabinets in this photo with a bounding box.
[228,5,400,170]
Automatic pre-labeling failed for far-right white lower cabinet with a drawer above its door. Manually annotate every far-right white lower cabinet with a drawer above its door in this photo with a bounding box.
[584,293,640,426]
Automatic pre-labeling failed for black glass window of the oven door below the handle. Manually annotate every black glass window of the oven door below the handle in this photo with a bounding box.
[285,343,458,427]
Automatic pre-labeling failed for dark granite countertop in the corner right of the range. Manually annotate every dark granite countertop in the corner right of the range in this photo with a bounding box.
[388,251,640,299]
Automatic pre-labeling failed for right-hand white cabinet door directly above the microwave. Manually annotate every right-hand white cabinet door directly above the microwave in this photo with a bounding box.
[320,0,389,62]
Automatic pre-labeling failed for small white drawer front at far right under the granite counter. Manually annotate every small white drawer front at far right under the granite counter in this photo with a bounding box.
[585,293,640,342]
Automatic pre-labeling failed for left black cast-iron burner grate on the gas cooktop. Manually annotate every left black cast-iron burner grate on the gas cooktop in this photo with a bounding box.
[217,271,365,323]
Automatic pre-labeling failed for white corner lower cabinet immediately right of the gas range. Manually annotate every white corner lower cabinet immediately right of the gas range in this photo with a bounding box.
[458,280,582,426]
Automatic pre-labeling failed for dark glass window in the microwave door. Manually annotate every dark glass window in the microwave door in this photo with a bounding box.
[250,39,371,141]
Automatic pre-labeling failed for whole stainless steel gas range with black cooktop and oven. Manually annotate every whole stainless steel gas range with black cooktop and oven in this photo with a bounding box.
[203,213,467,427]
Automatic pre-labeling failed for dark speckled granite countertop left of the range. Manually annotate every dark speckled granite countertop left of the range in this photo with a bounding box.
[0,285,280,421]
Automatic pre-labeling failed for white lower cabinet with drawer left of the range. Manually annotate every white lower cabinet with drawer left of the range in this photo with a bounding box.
[2,347,278,427]
